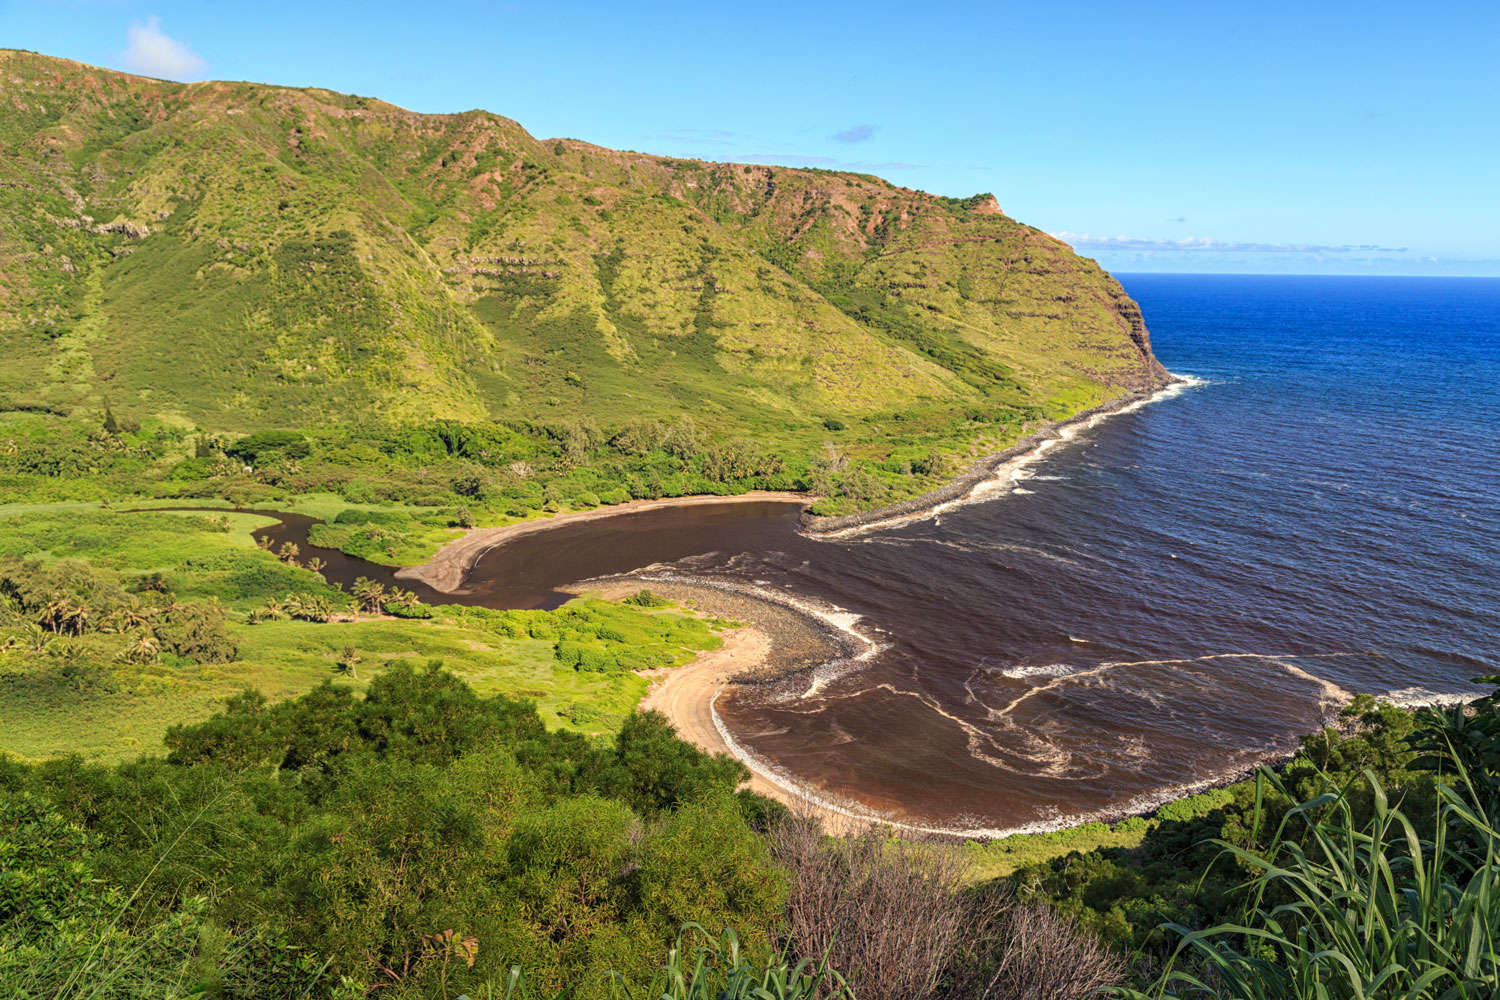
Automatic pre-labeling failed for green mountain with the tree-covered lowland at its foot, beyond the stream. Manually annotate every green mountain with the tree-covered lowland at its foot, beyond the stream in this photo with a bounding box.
[0,51,1163,524]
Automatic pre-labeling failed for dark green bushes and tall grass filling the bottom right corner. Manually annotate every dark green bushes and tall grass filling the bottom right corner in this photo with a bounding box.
[996,689,1500,1000]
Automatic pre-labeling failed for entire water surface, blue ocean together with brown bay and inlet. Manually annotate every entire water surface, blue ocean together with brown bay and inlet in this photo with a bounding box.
[258,276,1500,837]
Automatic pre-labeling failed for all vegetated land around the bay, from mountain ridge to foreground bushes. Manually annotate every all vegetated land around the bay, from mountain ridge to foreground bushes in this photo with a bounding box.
[0,51,1500,1000]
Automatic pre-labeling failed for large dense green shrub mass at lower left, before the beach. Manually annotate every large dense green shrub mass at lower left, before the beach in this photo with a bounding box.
[0,666,785,997]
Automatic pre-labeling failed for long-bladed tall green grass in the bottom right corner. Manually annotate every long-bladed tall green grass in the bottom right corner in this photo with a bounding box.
[1119,753,1500,1000]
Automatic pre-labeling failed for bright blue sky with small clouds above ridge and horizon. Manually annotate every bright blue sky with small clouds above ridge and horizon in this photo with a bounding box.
[0,0,1500,276]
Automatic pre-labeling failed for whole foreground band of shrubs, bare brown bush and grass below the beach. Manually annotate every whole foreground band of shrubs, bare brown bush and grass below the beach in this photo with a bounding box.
[0,666,1500,1000]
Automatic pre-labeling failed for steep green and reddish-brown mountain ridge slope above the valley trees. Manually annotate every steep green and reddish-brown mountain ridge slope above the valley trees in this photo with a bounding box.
[0,51,1164,438]
